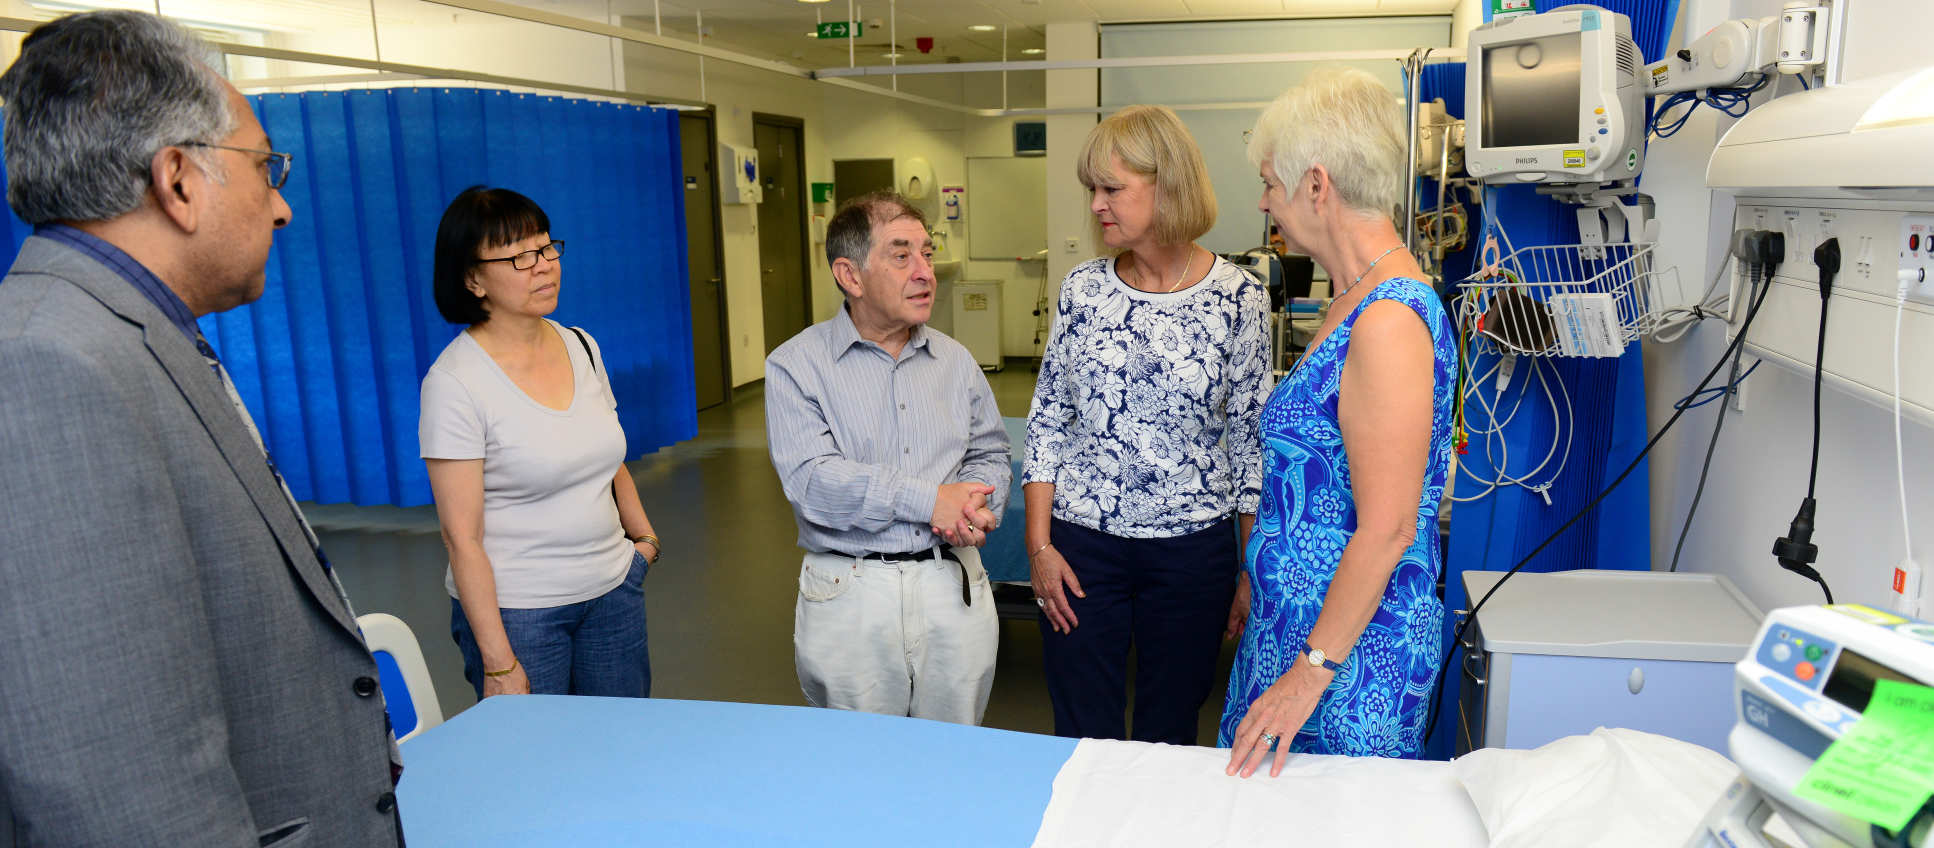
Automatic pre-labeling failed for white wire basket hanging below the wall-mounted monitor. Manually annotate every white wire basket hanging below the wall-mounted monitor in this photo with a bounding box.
[1456,242,1683,356]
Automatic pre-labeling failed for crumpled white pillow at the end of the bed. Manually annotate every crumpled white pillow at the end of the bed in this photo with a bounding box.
[1451,728,1739,848]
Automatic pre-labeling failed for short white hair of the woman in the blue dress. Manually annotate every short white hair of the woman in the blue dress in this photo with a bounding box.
[1249,68,1410,221]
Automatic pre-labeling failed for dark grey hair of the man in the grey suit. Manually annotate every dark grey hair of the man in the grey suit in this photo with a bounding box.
[0,12,236,225]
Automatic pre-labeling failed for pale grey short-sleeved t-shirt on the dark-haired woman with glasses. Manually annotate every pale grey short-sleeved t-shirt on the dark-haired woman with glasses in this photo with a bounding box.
[418,321,632,610]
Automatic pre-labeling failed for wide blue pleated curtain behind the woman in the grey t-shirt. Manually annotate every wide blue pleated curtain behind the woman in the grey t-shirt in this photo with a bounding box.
[190,89,696,505]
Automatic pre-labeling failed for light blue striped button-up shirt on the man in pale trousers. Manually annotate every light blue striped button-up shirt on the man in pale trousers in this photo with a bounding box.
[766,308,1011,554]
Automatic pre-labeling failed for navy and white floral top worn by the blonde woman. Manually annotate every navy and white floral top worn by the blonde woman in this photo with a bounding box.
[1023,257,1269,538]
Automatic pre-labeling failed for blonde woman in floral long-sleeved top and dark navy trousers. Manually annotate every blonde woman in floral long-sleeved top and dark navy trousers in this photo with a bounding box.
[1023,106,1269,745]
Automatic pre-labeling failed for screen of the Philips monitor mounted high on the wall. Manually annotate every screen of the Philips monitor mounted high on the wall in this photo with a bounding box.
[1483,33,1584,147]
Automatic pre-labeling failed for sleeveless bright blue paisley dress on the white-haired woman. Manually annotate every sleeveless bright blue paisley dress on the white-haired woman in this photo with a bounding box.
[1218,277,1456,759]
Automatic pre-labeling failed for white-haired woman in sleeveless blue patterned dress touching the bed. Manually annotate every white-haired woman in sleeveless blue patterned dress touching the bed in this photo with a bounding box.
[1220,72,1456,776]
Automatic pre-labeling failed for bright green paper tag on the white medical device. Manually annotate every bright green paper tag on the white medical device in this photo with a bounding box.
[1793,680,1934,833]
